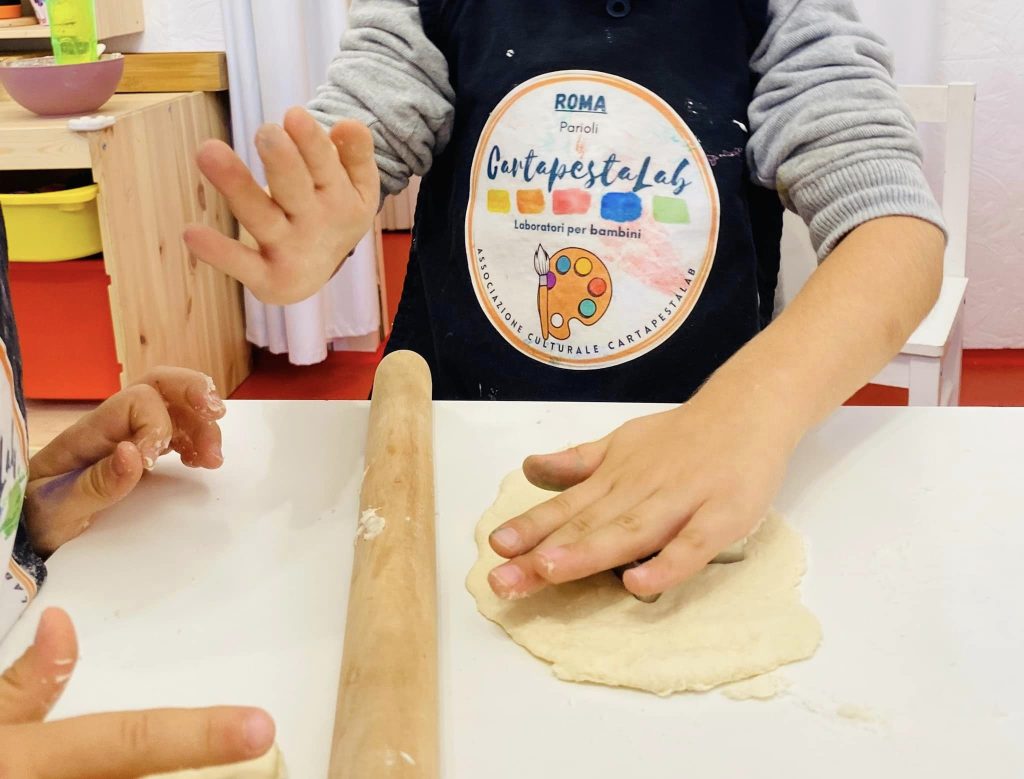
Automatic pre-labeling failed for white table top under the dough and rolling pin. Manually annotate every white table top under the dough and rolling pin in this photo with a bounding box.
[0,402,1024,779]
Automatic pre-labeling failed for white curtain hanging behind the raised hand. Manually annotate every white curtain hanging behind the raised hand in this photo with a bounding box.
[221,0,380,365]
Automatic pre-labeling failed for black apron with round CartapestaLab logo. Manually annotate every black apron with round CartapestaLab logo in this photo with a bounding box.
[388,0,782,402]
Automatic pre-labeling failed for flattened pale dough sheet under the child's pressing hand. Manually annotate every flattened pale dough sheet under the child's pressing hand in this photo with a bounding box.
[466,472,821,695]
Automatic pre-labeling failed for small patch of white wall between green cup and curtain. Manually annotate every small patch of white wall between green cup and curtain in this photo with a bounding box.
[110,0,225,51]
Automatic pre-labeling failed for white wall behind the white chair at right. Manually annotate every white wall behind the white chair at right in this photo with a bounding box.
[857,0,1024,348]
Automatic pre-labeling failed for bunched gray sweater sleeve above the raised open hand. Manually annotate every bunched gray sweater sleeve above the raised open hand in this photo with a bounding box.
[308,0,455,194]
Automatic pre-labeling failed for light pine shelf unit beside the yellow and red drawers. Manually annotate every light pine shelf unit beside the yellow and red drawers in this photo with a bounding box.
[0,92,250,395]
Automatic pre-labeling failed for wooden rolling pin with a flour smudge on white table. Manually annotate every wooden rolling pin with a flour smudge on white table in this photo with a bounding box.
[329,352,439,779]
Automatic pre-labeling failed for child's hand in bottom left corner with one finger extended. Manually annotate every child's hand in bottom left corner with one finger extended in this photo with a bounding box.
[0,609,274,779]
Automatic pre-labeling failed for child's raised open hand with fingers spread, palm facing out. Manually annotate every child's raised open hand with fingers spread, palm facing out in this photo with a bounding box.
[185,109,381,305]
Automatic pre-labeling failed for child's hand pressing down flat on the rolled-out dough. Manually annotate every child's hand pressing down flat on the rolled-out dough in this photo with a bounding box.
[489,401,794,598]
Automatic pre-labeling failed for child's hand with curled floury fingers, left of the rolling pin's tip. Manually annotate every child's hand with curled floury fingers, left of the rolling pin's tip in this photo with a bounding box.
[25,367,225,555]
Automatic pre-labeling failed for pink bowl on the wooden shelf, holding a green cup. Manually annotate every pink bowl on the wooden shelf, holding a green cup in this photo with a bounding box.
[0,54,125,117]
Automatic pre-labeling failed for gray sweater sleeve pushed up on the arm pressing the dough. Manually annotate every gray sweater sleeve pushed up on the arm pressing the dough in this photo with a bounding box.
[748,0,942,258]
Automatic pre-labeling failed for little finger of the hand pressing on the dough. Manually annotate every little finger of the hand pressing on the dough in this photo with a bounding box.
[623,504,737,596]
